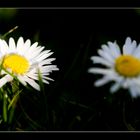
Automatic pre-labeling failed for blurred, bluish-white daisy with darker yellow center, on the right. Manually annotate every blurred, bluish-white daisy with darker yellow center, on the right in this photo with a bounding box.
[88,37,140,97]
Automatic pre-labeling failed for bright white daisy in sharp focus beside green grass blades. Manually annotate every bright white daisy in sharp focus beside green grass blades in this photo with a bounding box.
[0,37,59,90]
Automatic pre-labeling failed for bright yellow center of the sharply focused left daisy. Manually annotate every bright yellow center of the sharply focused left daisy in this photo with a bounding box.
[3,54,29,74]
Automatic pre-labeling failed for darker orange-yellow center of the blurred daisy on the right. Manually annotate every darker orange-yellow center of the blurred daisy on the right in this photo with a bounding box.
[115,55,140,77]
